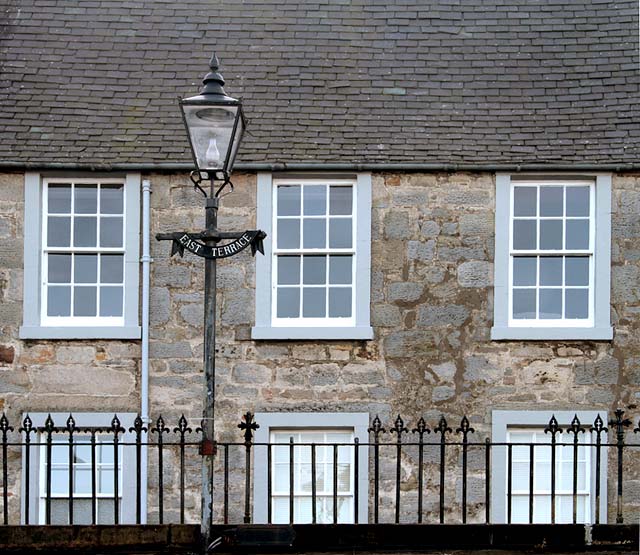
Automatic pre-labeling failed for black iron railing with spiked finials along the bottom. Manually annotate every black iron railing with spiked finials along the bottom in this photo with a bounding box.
[0,410,640,525]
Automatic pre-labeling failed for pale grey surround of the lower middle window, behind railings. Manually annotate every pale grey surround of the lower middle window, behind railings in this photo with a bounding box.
[253,412,369,524]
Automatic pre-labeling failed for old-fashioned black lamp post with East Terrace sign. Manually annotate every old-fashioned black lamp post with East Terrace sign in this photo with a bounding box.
[156,54,266,541]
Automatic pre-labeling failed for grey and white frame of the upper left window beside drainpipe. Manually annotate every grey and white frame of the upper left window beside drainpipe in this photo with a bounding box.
[19,172,141,339]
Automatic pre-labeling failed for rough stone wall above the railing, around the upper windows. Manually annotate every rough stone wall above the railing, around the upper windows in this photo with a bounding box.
[0,173,640,524]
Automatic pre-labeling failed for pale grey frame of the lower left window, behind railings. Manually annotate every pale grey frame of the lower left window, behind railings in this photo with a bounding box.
[20,412,138,524]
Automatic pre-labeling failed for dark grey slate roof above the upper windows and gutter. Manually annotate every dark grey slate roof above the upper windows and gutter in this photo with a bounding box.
[0,0,640,166]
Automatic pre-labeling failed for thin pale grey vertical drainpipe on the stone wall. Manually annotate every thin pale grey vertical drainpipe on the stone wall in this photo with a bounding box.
[140,179,151,524]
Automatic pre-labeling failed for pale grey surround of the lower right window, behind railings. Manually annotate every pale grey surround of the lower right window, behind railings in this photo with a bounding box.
[490,410,608,524]
